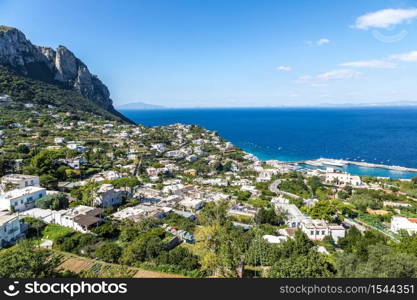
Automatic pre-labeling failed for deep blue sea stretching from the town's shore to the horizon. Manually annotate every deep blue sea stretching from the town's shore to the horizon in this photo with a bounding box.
[121,107,417,178]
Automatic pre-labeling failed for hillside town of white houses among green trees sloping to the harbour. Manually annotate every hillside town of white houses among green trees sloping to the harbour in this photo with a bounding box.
[0,91,417,277]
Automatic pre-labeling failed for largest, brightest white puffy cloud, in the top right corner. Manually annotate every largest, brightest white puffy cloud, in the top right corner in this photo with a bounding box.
[353,8,417,30]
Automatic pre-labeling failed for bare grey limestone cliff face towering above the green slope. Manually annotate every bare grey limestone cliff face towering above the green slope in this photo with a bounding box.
[0,26,114,111]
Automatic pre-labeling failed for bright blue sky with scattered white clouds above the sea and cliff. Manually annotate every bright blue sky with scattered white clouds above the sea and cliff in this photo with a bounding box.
[0,0,417,107]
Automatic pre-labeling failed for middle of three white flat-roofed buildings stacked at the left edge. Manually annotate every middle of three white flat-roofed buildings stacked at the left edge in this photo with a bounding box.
[0,186,46,211]
